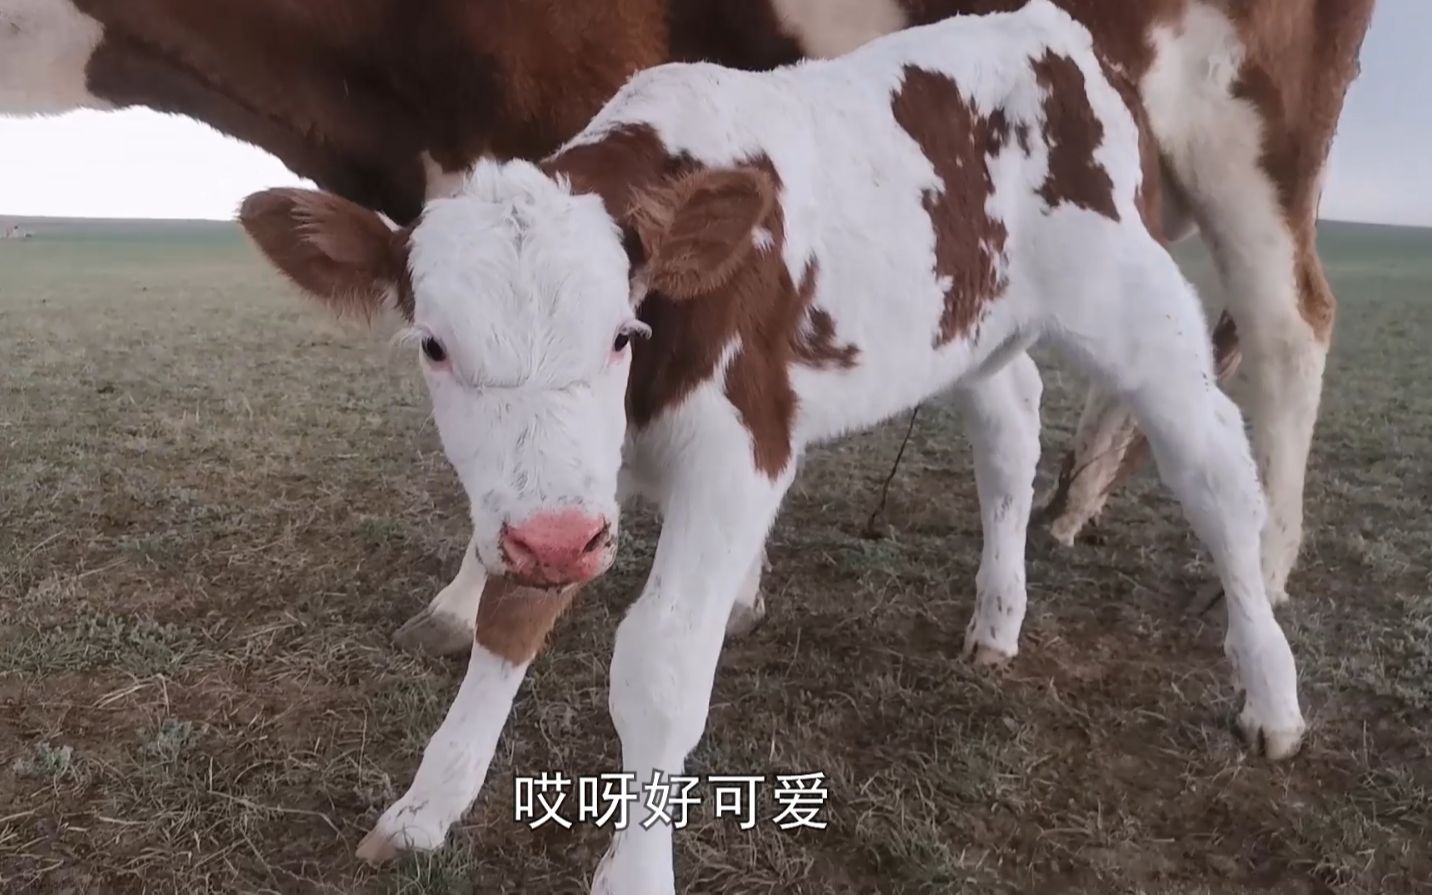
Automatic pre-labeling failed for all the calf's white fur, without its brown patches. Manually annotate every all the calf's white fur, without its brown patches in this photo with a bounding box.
[352,0,1303,895]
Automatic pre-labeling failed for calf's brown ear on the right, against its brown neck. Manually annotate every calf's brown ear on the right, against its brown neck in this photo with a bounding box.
[629,166,776,299]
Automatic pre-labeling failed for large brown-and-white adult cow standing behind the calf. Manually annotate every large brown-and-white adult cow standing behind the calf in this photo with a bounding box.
[0,0,1373,641]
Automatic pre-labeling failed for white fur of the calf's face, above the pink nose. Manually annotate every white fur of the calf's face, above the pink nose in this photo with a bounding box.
[411,162,634,573]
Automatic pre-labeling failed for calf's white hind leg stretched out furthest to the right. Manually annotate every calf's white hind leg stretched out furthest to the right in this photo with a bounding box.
[1057,247,1305,759]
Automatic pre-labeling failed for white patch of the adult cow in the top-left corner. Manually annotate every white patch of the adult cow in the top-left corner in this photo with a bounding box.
[0,0,110,115]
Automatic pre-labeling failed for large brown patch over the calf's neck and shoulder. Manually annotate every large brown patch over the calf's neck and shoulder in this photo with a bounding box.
[544,126,859,477]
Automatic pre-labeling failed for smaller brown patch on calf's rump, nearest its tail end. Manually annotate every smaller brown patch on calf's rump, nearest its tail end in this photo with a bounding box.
[1034,52,1118,221]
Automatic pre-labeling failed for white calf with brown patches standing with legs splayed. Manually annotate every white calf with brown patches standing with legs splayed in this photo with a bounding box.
[243,1,1303,895]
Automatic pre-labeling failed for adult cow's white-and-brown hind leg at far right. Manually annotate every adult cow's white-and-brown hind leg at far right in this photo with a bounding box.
[1122,1,1372,601]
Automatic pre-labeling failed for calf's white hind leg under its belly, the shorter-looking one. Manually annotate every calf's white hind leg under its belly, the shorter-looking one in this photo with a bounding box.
[955,354,1044,664]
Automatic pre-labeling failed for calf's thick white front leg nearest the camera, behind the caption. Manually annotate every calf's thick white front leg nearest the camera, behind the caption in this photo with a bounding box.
[591,402,792,895]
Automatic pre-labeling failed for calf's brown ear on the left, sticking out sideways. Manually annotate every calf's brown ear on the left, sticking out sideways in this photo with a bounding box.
[239,189,412,321]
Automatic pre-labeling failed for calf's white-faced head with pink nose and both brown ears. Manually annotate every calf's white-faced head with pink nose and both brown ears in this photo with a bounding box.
[239,162,773,587]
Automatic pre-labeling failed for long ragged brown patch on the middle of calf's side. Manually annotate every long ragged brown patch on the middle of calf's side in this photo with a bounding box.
[891,66,1010,347]
